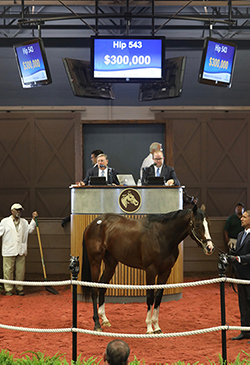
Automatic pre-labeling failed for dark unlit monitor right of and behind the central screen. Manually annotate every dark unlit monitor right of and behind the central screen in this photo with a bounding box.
[139,56,186,101]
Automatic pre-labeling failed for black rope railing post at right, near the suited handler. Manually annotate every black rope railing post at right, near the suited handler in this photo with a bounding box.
[218,254,228,364]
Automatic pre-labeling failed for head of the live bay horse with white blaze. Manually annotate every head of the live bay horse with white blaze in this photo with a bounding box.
[189,204,214,255]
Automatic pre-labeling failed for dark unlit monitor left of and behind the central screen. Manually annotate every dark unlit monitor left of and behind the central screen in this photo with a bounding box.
[63,58,115,99]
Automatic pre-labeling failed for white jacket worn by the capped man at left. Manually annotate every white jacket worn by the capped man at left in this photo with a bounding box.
[0,215,36,256]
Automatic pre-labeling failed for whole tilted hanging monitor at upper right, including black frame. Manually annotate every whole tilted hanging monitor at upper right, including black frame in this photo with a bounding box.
[199,38,236,87]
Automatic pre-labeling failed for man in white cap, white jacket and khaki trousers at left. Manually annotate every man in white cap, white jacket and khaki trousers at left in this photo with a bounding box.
[0,203,38,295]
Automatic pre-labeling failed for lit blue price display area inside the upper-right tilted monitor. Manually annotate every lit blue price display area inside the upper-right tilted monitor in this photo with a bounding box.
[202,40,235,83]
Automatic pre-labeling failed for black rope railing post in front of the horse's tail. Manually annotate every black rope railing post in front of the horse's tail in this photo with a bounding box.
[69,256,79,363]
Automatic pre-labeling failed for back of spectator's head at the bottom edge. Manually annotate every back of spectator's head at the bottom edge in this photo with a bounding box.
[104,340,130,365]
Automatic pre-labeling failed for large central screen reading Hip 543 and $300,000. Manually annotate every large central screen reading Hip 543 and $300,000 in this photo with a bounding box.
[91,37,165,82]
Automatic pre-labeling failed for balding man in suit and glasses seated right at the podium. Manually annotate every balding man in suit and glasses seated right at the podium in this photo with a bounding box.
[142,151,180,186]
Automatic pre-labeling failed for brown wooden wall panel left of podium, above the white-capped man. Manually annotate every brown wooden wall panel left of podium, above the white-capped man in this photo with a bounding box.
[0,113,80,217]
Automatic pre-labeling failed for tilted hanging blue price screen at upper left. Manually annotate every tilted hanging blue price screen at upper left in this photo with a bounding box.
[14,38,52,88]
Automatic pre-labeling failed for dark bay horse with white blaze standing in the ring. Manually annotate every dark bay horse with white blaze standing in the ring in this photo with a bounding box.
[82,205,214,333]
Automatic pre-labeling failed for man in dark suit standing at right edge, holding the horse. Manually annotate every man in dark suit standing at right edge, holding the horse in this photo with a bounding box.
[228,210,250,340]
